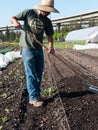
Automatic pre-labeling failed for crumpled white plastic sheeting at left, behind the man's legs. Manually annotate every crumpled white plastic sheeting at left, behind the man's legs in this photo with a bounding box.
[0,51,21,68]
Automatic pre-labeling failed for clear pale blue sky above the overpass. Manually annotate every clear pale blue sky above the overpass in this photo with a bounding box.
[0,0,98,27]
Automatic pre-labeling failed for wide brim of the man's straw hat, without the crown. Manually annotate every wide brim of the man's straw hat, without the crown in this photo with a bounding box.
[34,5,59,13]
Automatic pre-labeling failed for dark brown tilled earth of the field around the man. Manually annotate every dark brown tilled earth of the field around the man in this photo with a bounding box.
[0,48,98,130]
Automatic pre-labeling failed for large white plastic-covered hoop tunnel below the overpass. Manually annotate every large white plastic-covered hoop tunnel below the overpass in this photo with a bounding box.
[65,26,98,41]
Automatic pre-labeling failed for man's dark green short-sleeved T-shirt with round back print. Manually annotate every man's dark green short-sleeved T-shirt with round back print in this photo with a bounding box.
[16,9,54,49]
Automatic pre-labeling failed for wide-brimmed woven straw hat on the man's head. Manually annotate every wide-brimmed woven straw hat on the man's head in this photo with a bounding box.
[35,0,59,13]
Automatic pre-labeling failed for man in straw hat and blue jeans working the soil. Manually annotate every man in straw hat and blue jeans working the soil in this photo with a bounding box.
[10,0,58,107]
